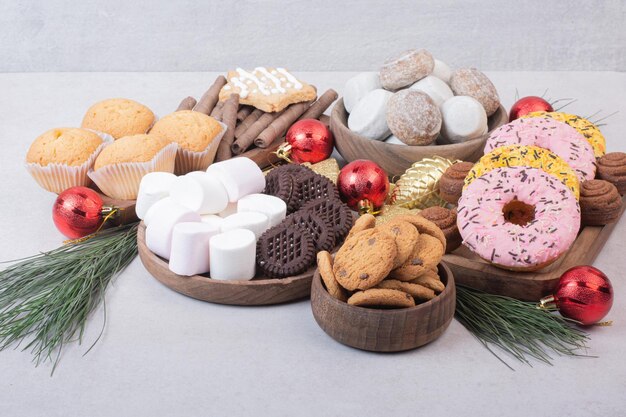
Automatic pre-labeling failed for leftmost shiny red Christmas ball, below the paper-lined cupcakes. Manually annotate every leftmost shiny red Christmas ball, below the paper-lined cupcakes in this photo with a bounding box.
[52,187,103,239]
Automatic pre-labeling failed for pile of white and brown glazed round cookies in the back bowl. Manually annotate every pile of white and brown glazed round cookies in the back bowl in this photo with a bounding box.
[343,49,500,146]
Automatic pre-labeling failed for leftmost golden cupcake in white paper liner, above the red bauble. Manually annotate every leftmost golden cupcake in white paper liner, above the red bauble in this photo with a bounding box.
[26,127,113,194]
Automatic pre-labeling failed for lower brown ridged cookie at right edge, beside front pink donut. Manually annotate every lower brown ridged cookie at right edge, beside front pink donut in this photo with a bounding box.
[580,180,622,226]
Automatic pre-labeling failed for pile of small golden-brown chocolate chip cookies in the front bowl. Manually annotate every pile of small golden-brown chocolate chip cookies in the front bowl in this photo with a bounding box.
[317,214,446,308]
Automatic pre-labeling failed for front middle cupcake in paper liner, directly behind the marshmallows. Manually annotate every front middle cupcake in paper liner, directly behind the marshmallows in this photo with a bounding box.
[88,134,178,200]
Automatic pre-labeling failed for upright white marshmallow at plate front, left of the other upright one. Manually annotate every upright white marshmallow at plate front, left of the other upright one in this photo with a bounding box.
[169,223,220,276]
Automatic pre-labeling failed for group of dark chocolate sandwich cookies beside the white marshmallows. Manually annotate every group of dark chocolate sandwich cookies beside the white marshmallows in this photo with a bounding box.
[257,164,353,278]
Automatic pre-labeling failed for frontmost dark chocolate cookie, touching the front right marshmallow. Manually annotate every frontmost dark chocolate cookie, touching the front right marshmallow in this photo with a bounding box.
[256,222,315,278]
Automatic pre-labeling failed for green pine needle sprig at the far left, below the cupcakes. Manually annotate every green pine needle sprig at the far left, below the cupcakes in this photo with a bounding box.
[0,224,137,372]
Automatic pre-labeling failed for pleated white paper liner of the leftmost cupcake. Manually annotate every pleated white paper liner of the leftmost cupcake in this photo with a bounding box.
[26,129,114,194]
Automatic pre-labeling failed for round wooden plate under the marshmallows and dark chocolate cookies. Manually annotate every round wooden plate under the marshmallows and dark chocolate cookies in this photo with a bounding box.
[137,222,315,306]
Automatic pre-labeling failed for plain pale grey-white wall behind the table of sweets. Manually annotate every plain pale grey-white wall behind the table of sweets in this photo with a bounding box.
[0,0,626,71]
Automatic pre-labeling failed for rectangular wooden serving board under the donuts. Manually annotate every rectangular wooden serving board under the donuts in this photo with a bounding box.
[443,197,626,301]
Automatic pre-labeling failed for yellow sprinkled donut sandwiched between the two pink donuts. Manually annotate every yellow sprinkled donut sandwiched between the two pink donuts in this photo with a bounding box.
[463,145,580,199]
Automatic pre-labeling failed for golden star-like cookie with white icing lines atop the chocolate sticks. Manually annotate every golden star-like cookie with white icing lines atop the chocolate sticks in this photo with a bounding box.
[219,67,317,113]
